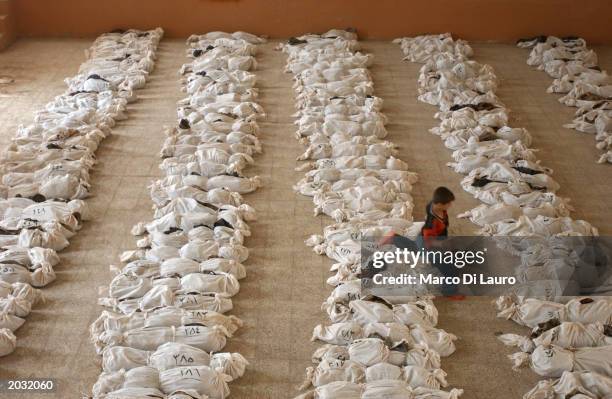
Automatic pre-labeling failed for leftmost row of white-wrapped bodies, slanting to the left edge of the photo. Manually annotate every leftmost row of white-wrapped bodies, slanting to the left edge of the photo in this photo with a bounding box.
[0,29,163,356]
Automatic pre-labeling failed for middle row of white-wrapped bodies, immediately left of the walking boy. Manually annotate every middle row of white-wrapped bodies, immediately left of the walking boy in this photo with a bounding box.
[280,30,462,399]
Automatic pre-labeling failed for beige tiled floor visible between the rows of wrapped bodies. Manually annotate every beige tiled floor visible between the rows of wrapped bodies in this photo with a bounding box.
[0,39,612,399]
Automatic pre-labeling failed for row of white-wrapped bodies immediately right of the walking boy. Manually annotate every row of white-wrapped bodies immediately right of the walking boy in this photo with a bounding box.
[397,34,612,398]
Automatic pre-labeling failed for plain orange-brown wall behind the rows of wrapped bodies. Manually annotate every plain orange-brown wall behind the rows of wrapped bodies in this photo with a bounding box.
[15,0,612,43]
